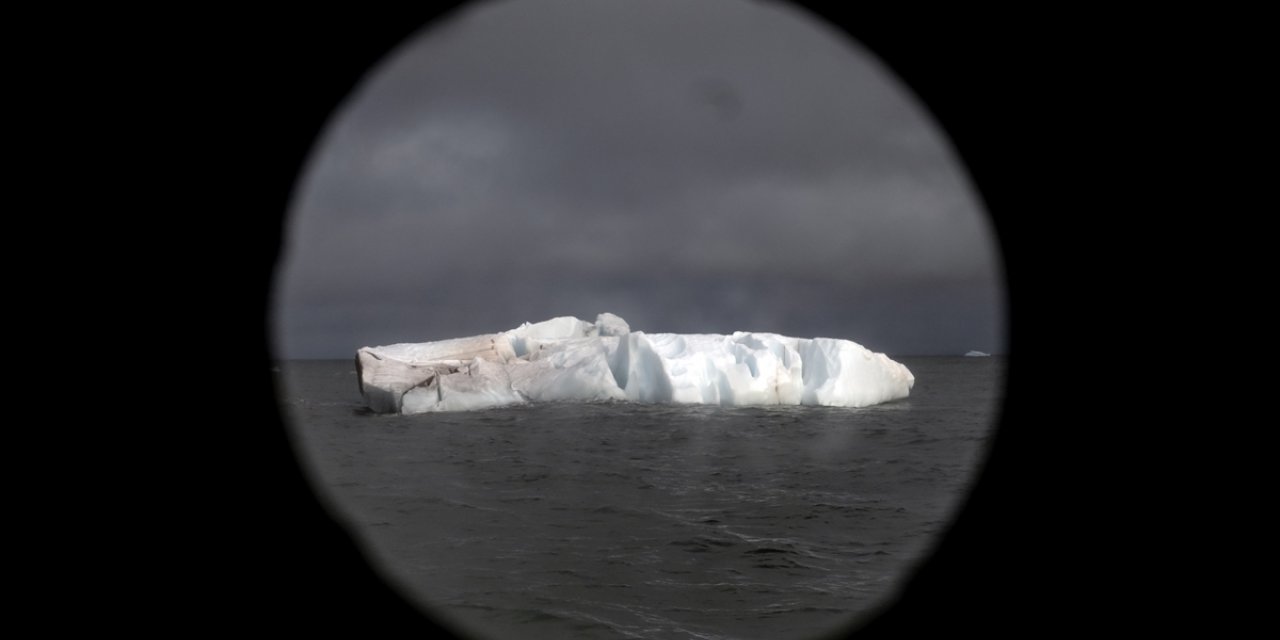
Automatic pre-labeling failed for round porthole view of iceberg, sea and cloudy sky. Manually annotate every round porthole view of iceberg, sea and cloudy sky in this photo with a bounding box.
[273,0,1006,639]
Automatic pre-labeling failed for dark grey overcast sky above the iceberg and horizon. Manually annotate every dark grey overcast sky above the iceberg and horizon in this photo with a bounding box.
[275,0,1005,358]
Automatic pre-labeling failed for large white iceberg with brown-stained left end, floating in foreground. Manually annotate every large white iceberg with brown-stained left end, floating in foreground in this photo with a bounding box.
[356,314,915,413]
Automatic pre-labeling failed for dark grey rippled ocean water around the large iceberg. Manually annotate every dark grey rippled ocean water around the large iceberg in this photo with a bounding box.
[280,357,1004,639]
